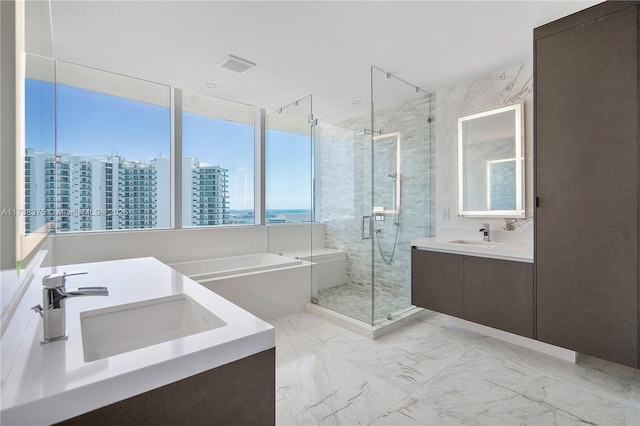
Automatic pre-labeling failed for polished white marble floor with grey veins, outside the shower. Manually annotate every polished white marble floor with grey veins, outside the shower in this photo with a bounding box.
[271,313,640,426]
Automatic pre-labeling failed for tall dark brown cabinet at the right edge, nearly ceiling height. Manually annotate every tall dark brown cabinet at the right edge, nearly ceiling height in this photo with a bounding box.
[534,1,640,368]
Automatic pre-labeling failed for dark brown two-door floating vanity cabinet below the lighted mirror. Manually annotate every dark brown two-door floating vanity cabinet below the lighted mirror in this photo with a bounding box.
[411,247,533,337]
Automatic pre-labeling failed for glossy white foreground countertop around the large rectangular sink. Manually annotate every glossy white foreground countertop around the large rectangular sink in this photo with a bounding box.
[1,257,275,425]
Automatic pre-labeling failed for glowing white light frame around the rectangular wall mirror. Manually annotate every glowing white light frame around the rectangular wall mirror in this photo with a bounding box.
[458,102,525,218]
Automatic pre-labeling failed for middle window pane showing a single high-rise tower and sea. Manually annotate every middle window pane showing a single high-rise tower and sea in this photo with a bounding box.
[182,91,255,227]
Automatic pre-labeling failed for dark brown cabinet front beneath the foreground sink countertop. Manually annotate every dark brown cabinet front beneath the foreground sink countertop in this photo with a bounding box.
[56,348,276,426]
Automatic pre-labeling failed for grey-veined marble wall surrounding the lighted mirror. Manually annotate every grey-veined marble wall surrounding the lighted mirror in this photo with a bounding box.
[433,62,533,236]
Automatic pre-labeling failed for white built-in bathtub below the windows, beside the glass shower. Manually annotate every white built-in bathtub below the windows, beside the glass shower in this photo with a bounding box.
[169,253,311,321]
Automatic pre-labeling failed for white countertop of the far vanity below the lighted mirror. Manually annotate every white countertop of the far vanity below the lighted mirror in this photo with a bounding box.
[411,237,533,263]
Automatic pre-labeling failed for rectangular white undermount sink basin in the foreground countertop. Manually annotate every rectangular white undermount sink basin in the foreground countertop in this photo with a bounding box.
[80,294,226,362]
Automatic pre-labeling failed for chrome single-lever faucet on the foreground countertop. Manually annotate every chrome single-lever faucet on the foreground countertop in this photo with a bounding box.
[31,271,109,343]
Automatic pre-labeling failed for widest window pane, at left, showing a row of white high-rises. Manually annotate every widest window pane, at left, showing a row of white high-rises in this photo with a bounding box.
[54,61,171,232]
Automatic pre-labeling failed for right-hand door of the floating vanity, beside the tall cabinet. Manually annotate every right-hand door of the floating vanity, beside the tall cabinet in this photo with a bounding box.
[464,256,533,338]
